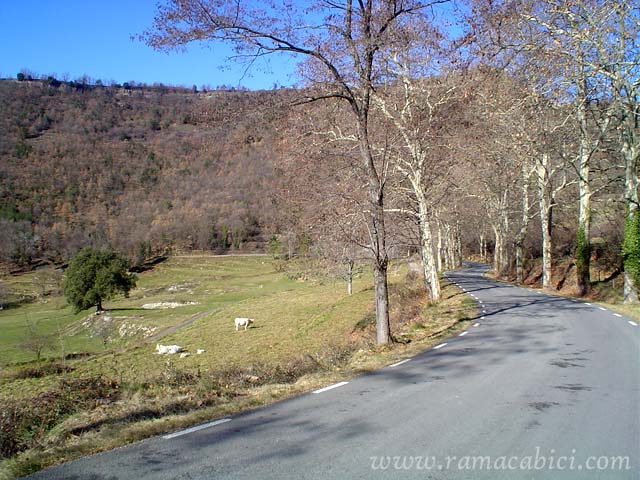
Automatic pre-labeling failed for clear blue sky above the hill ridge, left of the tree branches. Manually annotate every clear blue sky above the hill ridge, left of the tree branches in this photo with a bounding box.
[0,0,295,89]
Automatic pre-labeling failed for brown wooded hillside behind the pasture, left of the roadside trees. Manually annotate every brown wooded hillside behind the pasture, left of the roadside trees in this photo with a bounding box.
[0,80,292,263]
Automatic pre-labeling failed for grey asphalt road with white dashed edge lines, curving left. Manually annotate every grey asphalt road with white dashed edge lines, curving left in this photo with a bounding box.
[26,264,640,480]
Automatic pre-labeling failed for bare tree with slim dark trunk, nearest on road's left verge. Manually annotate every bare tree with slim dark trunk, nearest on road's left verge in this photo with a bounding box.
[142,0,450,344]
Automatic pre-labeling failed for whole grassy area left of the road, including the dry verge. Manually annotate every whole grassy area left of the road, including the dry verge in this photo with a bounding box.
[0,253,475,479]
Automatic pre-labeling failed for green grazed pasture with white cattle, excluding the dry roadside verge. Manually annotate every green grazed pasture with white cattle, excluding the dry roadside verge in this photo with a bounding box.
[0,257,372,390]
